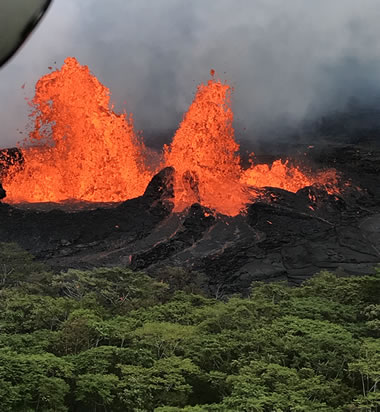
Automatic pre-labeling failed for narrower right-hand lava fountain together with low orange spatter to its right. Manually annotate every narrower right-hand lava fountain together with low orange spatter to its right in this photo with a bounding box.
[165,71,338,216]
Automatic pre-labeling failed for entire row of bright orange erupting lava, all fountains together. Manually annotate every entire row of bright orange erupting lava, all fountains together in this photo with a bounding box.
[2,57,338,216]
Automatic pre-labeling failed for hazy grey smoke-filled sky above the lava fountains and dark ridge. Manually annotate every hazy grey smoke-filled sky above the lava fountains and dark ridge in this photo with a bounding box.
[0,0,380,147]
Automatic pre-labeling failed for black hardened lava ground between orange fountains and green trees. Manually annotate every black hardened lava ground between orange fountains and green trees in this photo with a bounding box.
[0,147,380,296]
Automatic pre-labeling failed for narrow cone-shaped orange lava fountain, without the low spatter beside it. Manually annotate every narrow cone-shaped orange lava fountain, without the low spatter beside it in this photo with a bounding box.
[165,76,249,215]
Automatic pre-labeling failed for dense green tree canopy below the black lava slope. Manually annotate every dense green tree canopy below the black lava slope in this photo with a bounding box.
[0,244,380,412]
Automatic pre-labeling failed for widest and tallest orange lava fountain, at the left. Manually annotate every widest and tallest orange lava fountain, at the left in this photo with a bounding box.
[3,58,151,203]
